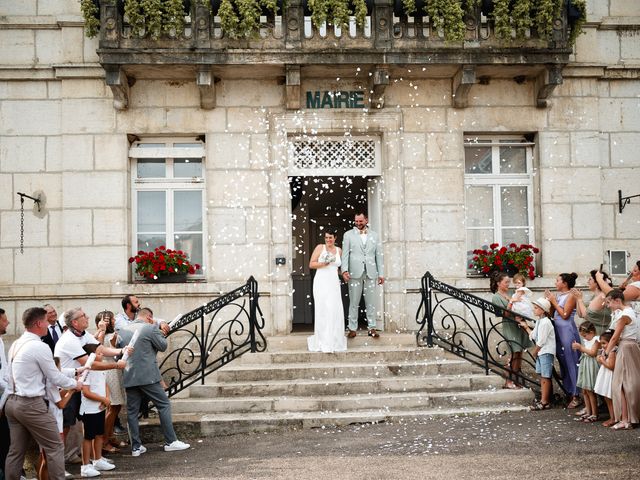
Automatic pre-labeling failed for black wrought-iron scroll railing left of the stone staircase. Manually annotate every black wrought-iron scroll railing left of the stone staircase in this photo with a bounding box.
[160,277,267,396]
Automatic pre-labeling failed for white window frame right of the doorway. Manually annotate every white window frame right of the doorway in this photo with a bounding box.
[463,134,537,276]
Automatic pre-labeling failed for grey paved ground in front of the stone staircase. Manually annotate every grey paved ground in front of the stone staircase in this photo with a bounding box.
[67,409,640,480]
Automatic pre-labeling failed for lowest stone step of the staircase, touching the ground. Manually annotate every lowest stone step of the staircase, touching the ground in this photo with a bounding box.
[141,403,528,442]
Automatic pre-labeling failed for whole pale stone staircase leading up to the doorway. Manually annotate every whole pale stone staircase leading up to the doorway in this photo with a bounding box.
[140,334,533,437]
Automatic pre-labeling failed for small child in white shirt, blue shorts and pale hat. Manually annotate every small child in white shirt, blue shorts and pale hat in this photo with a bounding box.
[519,298,556,411]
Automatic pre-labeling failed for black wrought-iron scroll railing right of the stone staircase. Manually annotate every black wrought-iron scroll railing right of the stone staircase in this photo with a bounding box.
[416,272,566,393]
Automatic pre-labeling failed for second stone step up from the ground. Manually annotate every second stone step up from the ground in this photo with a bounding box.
[172,389,533,414]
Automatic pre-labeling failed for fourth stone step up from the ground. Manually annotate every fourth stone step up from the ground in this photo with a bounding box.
[209,359,479,382]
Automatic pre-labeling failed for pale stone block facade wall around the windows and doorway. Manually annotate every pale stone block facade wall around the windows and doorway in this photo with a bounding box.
[0,0,640,334]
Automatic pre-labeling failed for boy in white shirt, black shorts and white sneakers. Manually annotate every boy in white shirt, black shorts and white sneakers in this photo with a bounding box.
[80,353,116,477]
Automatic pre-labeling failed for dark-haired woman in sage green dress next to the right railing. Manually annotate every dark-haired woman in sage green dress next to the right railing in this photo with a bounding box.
[489,272,531,388]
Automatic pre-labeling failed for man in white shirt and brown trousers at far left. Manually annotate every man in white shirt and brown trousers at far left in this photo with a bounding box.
[5,307,81,480]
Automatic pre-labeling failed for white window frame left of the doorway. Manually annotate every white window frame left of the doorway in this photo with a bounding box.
[129,137,208,280]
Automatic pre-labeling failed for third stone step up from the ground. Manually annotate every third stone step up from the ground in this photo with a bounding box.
[189,373,504,398]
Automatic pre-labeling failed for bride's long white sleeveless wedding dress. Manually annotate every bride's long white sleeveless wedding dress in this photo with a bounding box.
[307,246,347,353]
